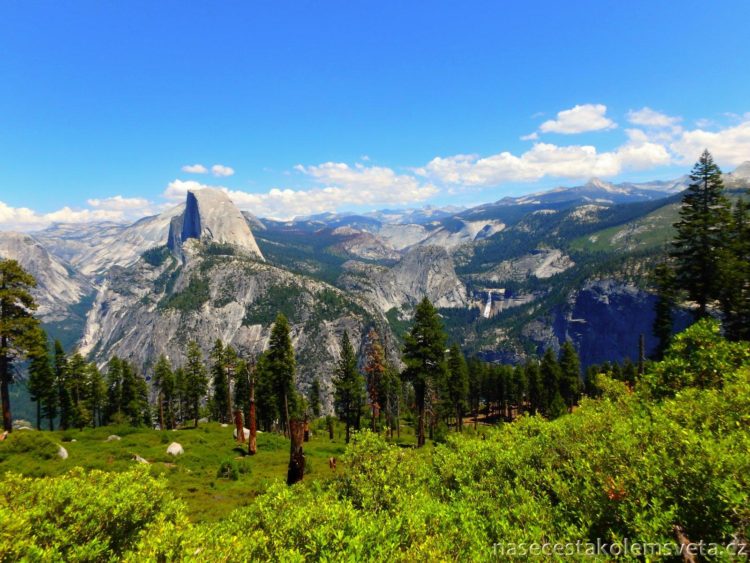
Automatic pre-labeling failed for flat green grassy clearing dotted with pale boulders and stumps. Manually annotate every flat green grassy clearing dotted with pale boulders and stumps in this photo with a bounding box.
[0,422,424,522]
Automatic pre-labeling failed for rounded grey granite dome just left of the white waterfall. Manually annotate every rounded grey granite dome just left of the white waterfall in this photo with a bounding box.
[340,246,469,312]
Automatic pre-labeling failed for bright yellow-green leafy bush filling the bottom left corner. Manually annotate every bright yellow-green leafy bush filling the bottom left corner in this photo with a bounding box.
[0,468,187,561]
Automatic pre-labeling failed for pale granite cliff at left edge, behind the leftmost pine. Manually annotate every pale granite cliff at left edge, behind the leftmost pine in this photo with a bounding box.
[0,232,94,323]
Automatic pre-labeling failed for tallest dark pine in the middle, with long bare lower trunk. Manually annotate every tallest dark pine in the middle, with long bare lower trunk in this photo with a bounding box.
[404,297,446,447]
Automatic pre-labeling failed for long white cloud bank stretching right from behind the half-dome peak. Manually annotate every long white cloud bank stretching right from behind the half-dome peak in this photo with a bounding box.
[164,162,438,219]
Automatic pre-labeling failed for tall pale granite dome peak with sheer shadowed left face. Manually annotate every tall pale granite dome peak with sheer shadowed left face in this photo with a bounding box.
[168,188,263,260]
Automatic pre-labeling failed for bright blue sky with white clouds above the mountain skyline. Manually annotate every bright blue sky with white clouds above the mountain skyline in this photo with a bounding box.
[0,0,750,228]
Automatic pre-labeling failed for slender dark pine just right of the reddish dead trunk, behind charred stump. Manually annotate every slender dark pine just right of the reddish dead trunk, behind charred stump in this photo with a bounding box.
[266,313,299,432]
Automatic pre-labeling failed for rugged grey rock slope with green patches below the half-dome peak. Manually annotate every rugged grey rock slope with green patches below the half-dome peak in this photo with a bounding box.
[81,240,394,410]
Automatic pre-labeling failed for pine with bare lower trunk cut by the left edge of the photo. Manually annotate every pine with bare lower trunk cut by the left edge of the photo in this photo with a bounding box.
[0,260,39,432]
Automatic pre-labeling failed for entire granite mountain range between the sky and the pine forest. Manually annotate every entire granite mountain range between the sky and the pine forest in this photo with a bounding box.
[0,162,750,407]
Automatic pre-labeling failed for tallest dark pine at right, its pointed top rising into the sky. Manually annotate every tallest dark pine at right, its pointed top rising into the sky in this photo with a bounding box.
[672,151,731,318]
